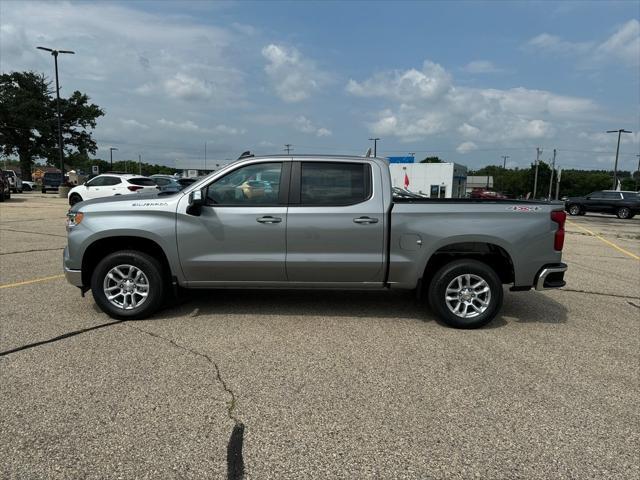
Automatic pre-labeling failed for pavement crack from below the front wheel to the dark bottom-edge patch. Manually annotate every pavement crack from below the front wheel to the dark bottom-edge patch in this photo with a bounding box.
[126,324,245,480]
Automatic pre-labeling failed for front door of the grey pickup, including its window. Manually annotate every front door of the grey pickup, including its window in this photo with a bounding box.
[176,161,291,286]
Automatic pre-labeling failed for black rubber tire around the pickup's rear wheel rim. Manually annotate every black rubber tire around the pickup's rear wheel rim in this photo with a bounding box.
[428,259,503,328]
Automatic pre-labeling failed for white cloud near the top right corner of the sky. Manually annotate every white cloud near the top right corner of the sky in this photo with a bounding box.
[525,18,640,68]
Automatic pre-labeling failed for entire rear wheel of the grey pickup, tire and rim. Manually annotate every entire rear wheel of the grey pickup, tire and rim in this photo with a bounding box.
[429,259,503,328]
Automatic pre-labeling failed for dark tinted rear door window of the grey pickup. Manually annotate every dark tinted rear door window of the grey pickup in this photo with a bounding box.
[300,162,369,205]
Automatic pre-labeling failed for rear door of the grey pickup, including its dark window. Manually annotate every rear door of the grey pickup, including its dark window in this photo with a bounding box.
[287,161,385,283]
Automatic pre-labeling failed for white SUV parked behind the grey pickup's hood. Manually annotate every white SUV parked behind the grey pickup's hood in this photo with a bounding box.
[68,173,158,205]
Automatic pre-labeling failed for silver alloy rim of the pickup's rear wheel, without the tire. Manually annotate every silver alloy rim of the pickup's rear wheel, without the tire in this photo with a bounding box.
[445,273,491,318]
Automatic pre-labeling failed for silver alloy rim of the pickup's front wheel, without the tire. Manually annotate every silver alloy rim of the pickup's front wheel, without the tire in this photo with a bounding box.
[102,265,149,310]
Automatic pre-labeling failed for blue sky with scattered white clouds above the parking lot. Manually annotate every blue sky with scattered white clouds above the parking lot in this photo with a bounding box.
[0,1,640,170]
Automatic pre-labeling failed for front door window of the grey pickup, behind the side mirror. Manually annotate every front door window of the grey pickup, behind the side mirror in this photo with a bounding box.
[207,162,282,205]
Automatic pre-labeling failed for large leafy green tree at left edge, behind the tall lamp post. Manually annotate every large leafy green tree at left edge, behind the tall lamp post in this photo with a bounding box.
[0,72,104,179]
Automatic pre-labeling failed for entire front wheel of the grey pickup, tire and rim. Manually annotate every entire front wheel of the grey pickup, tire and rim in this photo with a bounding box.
[91,250,165,320]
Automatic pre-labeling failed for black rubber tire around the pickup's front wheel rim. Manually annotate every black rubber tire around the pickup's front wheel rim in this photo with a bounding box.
[91,250,167,320]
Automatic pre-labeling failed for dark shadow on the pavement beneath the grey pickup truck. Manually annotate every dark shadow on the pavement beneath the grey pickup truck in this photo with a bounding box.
[150,290,567,328]
